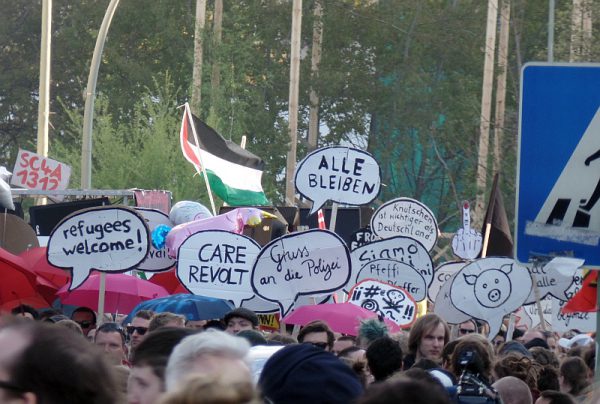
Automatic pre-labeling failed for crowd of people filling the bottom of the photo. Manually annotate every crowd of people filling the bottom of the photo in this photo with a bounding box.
[0,306,600,404]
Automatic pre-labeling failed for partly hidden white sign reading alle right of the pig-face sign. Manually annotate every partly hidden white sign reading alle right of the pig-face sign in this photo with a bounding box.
[525,257,584,304]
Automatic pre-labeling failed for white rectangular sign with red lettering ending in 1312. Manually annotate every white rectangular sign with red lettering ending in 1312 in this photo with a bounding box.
[10,149,71,191]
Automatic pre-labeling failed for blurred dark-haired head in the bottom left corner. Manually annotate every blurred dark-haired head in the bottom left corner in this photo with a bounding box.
[0,321,118,404]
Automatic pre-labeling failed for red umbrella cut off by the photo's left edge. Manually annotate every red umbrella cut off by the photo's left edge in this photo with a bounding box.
[0,248,50,311]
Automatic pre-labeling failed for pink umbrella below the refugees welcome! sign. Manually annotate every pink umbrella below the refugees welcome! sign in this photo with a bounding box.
[56,273,169,313]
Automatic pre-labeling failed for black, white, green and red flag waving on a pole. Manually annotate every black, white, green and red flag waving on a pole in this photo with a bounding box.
[180,103,269,206]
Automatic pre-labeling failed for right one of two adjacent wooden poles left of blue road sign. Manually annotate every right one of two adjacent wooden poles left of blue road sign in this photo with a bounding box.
[493,0,510,173]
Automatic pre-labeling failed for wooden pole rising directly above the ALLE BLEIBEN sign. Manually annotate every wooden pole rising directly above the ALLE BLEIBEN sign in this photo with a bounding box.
[308,0,323,153]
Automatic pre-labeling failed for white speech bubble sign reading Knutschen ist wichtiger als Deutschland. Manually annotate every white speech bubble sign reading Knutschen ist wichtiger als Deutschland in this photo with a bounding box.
[371,198,438,251]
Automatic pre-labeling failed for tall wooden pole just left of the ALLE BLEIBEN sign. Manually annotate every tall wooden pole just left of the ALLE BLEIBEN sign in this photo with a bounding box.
[285,0,302,206]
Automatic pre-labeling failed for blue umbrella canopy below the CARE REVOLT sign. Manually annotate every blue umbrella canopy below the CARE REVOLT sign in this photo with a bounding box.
[125,294,234,322]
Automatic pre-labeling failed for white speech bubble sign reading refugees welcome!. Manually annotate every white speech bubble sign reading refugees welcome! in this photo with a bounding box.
[47,206,150,290]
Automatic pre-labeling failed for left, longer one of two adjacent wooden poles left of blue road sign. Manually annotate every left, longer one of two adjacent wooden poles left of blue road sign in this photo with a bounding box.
[474,0,498,227]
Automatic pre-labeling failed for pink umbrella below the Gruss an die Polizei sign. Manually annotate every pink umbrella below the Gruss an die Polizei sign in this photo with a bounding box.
[282,303,400,335]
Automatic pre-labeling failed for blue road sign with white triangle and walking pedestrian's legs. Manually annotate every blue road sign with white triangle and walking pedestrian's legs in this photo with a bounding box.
[515,63,600,267]
